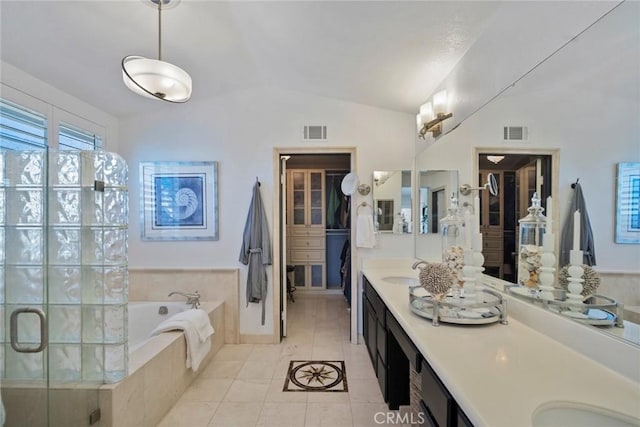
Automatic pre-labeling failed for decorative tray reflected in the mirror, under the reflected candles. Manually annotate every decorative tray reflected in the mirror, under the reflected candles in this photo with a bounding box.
[507,285,624,328]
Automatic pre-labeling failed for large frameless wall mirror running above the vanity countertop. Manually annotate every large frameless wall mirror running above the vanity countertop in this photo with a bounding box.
[416,2,640,345]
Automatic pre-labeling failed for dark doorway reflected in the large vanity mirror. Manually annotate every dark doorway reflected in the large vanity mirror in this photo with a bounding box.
[476,148,558,283]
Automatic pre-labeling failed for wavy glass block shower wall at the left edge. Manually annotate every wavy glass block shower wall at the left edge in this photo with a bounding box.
[0,150,128,382]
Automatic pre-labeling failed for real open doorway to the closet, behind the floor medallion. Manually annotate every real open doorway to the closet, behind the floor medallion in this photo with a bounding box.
[273,148,358,343]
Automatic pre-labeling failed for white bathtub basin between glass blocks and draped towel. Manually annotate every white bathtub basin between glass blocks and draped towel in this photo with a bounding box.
[128,301,191,355]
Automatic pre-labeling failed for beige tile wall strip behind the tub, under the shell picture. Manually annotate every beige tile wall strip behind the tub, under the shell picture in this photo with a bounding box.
[129,268,240,344]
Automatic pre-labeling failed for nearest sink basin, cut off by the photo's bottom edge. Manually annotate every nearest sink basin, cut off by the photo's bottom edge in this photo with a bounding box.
[532,402,640,427]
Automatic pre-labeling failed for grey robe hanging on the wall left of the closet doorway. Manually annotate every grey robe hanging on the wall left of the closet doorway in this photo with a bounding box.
[239,181,271,325]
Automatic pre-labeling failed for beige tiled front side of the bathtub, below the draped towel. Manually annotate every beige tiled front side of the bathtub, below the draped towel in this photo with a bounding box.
[100,301,225,427]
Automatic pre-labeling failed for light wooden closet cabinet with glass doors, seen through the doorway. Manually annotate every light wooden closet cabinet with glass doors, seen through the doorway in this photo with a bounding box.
[287,169,327,289]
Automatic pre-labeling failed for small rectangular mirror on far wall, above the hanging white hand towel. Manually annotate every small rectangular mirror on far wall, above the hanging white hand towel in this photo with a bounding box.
[373,170,413,234]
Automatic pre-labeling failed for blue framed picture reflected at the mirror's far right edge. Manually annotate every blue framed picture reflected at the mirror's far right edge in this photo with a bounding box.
[615,162,640,245]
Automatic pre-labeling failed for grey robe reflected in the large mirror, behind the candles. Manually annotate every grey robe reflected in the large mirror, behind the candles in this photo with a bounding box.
[559,182,596,267]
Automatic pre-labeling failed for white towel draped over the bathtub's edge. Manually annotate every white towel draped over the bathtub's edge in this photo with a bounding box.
[151,308,214,371]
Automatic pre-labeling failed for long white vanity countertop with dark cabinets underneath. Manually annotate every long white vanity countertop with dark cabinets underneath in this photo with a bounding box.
[363,266,640,427]
